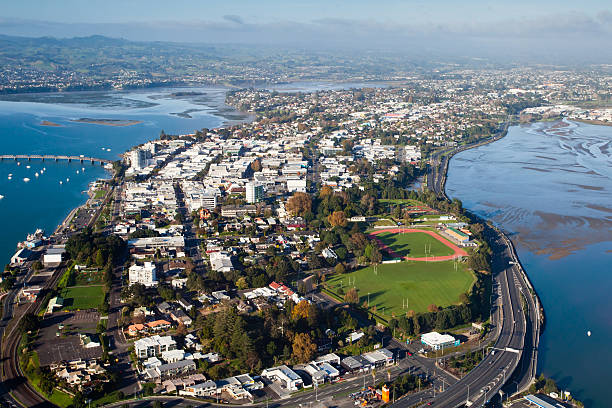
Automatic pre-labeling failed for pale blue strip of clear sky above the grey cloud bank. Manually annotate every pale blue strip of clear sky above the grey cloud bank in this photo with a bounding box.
[0,0,612,24]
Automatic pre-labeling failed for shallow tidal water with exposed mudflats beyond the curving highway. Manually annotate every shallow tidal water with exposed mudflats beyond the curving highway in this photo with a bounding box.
[446,120,612,407]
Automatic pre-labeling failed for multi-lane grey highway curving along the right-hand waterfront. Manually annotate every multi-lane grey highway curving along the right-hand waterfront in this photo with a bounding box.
[402,121,541,408]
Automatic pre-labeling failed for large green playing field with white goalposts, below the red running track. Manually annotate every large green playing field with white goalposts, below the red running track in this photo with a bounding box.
[325,261,475,317]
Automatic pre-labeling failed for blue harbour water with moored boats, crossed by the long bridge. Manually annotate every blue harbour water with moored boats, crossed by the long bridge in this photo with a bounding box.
[0,88,234,263]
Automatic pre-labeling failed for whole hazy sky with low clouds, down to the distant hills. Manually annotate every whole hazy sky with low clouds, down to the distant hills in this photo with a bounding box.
[0,0,612,59]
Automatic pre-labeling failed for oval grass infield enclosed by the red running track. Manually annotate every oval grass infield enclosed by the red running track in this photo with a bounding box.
[376,232,453,258]
